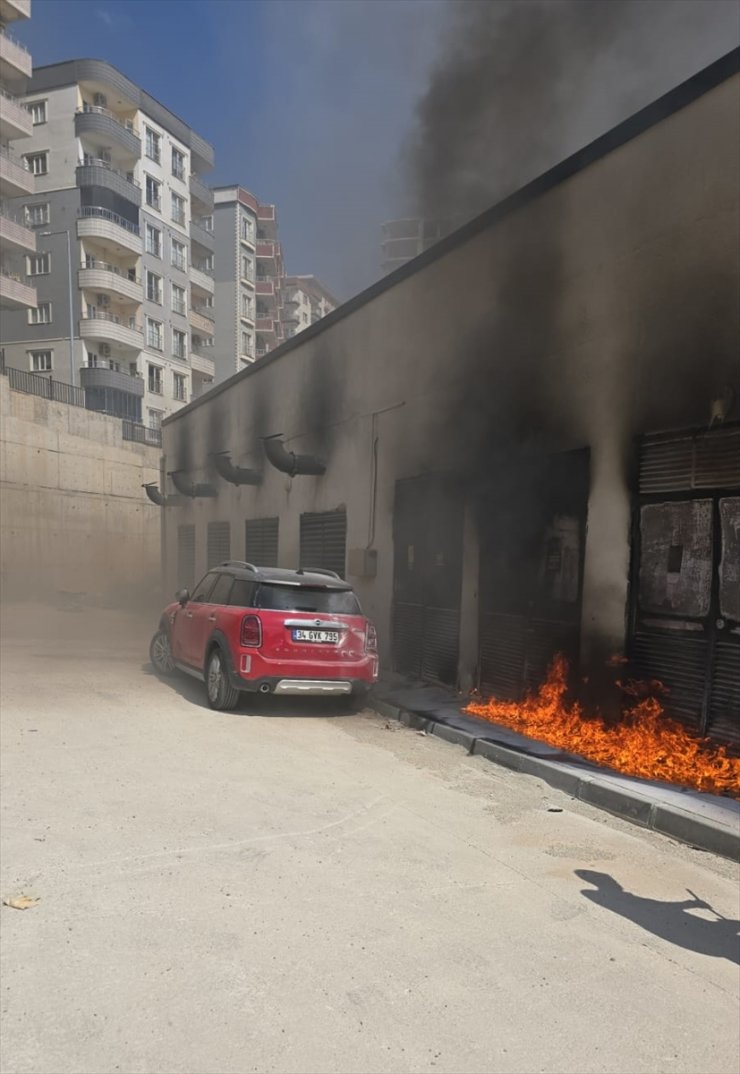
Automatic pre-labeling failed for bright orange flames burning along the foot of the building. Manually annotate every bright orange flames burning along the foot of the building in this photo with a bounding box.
[464,656,740,796]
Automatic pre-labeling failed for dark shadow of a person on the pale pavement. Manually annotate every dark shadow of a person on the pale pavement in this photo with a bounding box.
[575,869,740,964]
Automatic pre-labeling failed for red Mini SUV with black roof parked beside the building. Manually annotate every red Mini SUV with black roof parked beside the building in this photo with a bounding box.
[149,562,378,709]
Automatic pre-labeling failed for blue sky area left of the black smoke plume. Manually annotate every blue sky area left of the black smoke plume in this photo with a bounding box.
[12,0,446,299]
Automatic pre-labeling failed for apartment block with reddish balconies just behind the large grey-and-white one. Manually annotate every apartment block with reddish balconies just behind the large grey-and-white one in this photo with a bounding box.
[214,186,285,380]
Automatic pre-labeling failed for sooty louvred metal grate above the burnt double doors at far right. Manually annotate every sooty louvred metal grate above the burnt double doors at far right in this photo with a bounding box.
[640,425,740,495]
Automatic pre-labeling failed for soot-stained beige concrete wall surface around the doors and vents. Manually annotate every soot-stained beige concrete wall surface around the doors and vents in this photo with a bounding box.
[158,67,740,679]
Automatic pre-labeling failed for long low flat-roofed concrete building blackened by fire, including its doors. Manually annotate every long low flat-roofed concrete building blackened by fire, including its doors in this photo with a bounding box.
[154,50,740,746]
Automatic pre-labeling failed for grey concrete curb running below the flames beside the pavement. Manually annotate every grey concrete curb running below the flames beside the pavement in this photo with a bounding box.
[369,694,740,861]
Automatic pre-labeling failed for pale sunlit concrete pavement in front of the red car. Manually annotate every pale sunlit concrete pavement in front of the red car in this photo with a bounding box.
[0,607,740,1074]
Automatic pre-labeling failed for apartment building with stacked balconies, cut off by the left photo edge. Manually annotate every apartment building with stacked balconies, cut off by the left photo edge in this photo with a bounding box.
[0,0,37,317]
